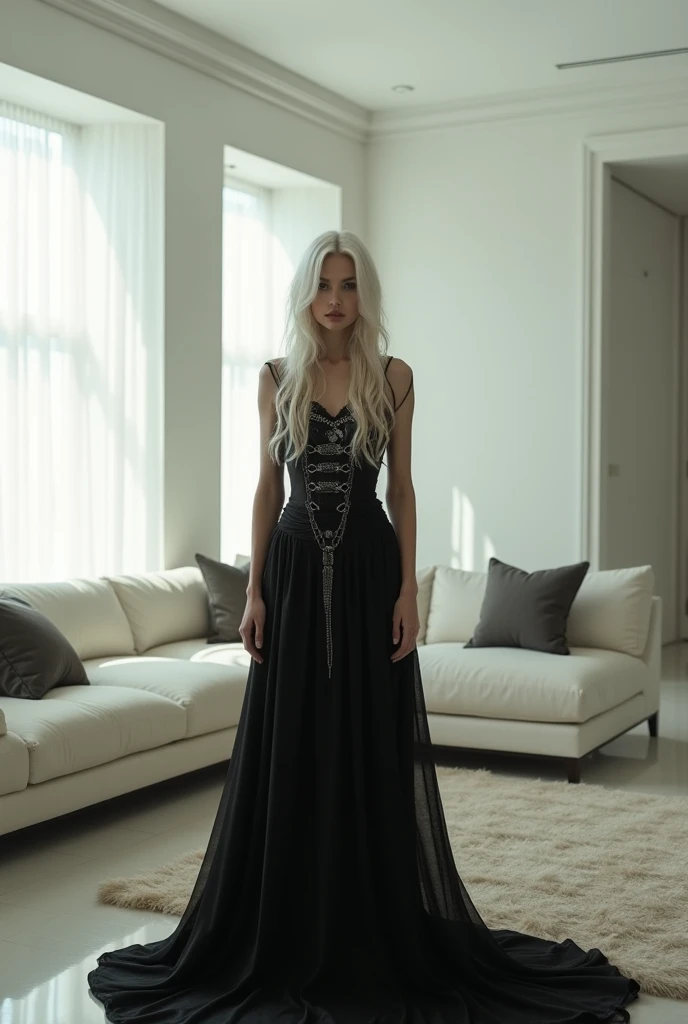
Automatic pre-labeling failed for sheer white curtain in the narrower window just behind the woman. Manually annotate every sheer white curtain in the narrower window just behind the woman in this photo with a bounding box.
[220,181,276,562]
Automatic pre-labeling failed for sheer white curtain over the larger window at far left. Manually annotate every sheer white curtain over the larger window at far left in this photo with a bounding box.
[0,104,163,582]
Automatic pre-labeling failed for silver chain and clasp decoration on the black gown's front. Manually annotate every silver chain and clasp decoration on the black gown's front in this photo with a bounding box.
[303,410,355,679]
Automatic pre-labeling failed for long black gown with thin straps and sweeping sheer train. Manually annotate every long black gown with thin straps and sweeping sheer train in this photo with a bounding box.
[88,364,639,1024]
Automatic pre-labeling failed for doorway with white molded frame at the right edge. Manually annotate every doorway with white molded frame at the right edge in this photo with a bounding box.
[582,129,688,643]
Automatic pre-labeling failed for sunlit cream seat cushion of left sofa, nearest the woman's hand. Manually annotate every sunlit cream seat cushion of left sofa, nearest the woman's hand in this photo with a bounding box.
[86,654,247,736]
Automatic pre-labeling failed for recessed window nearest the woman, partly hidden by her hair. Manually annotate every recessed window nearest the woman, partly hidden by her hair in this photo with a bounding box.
[220,151,341,562]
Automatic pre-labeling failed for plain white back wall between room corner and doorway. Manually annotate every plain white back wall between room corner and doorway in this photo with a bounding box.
[369,105,688,569]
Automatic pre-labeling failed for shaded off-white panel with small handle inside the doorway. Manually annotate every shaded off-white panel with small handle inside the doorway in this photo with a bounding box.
[600,179,682,643]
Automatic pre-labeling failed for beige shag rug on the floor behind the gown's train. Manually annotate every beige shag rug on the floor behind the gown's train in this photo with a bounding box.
[98,767,688,999]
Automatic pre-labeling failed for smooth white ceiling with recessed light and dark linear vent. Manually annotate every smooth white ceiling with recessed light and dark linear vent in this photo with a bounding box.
[151,0,688,111]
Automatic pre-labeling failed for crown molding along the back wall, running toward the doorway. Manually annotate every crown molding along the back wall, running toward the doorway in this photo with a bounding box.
[369,77,688,139]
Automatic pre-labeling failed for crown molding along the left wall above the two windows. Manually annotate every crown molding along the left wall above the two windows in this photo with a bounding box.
[41,0,370,141]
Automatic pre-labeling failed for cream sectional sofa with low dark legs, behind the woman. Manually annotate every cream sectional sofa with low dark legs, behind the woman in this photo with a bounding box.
[0,566,661,835]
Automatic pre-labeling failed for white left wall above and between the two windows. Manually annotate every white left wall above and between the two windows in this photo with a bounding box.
[0,0,366,566]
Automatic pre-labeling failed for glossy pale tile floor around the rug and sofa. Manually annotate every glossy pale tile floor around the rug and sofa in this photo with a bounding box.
[0,645,688,1024]
